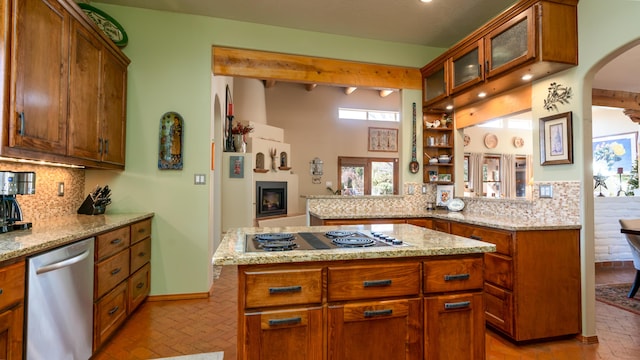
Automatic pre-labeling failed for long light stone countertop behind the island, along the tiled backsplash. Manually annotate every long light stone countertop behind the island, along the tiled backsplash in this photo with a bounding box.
[309,210,582,231]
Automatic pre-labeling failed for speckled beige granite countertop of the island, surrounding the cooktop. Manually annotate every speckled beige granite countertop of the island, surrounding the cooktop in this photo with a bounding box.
[212,224,496,265]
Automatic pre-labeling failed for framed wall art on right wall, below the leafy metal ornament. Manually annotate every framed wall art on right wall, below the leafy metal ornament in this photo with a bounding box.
[540,111,573,166]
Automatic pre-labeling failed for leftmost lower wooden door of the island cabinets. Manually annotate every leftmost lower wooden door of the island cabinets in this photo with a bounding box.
[243,307,324,360]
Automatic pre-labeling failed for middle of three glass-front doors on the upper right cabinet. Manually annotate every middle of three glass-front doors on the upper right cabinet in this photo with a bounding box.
[450,39,484,94]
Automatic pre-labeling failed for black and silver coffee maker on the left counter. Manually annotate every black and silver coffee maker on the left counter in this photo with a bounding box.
[0,171,36,233]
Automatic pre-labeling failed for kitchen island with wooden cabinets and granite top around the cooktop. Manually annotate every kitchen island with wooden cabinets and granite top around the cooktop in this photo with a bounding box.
[213,224,496,360]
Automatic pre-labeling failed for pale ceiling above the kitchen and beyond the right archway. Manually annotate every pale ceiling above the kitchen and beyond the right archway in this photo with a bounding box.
[92,0,640,92]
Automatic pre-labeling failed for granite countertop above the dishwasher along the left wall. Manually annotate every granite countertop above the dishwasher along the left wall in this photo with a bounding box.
[0,213,154,262]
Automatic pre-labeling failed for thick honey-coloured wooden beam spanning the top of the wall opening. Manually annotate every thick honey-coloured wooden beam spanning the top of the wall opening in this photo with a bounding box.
[212,46,422,90]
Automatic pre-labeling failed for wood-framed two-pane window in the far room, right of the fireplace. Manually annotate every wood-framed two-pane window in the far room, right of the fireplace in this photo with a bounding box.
[338,156,398,195]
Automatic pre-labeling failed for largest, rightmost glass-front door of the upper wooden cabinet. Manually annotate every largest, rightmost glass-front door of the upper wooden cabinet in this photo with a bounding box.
[485,7,536,78]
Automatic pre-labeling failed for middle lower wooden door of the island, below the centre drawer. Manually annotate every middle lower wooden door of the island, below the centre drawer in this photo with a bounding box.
[327,299,422,360]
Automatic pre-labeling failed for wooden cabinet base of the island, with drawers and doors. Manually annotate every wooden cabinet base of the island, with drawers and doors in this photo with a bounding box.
[238,254,484,360]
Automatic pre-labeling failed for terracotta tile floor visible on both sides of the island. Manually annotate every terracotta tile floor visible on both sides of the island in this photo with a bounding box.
[93,263,640,360]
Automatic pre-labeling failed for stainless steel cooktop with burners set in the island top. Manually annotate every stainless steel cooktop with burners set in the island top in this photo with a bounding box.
[245,230,407,252]
